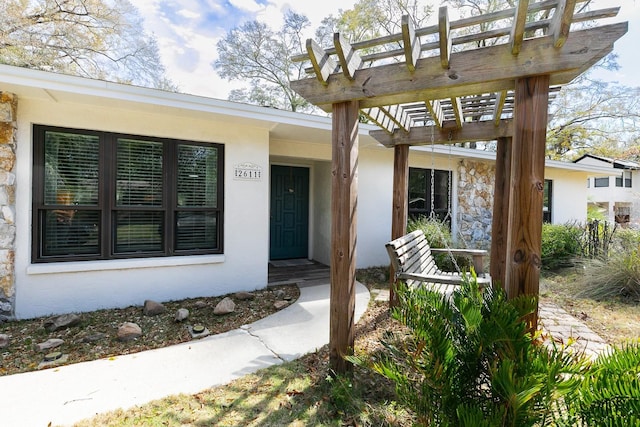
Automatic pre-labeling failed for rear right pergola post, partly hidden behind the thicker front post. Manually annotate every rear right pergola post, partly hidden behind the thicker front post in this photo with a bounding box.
[489,137,512,289]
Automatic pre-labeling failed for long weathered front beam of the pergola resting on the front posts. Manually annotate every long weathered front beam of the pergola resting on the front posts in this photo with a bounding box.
[291,22,628,111]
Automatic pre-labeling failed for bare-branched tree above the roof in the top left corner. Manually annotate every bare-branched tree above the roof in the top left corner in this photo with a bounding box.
[0,0,176,90]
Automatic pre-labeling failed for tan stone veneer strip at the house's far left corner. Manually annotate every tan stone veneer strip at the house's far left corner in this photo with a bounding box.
[0,92,18,323]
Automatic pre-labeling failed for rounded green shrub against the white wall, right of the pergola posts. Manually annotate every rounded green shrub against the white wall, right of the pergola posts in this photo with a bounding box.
[541,224,584,270]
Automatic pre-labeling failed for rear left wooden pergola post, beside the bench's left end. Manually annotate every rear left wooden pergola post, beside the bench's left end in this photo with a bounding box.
[389,145,409,308]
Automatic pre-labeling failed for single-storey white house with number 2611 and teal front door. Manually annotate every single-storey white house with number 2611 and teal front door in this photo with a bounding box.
[0,66,608,318]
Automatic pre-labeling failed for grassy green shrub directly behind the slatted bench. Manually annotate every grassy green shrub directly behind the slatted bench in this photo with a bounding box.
[407,216,472,271]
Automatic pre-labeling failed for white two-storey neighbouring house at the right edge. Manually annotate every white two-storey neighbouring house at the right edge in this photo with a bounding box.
[574,154,640,228]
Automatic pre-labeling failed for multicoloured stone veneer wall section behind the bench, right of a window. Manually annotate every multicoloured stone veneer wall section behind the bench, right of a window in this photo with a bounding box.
[458,159,496,249]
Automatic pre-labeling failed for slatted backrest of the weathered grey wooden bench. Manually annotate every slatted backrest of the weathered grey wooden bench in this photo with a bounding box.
[385,230,441,284]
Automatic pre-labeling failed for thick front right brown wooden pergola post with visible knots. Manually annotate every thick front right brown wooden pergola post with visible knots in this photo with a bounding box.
[505,75,550,331]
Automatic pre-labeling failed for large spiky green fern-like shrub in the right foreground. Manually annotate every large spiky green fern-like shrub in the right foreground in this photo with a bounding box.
[348,278,640,427]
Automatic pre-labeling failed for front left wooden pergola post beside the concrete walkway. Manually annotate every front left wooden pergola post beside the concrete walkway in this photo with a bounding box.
[329,101,359,374]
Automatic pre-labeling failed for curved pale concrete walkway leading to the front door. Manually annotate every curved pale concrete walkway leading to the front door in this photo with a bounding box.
[0,281,369,427]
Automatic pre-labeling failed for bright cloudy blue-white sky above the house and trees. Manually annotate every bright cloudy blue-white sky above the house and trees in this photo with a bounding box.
[132,0,640,99]
